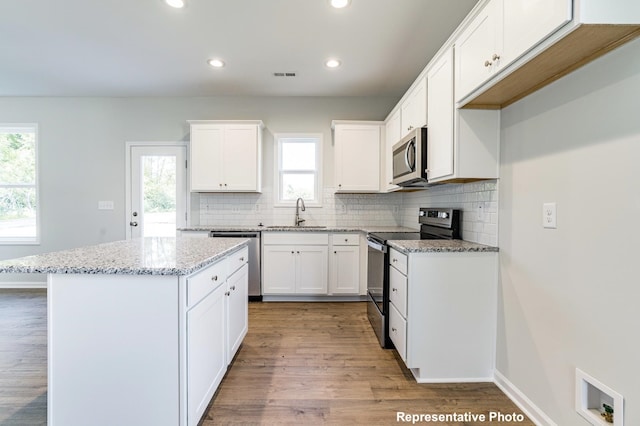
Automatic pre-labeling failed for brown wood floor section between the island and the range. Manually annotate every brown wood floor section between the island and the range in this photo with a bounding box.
[201,303,533,426]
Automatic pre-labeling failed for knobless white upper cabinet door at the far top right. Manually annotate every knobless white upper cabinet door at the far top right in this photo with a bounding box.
[503,0,571,63]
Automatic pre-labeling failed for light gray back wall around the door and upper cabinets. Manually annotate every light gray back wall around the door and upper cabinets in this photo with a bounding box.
[0,97,397,266]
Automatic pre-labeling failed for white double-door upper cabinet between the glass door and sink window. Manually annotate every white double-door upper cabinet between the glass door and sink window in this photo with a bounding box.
[189,121,262,192]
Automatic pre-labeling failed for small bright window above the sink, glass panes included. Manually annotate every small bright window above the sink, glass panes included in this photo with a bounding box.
[275,134,322,206]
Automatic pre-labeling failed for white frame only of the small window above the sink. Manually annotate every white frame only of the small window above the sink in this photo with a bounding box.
[273,133,324,207]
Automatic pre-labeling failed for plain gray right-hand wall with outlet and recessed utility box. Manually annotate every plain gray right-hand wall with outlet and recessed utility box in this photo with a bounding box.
[497,40,640,425]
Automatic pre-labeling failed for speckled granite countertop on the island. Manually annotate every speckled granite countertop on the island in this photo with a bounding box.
[0,237,249,275]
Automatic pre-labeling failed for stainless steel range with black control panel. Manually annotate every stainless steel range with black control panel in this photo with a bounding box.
[367,207,461,349]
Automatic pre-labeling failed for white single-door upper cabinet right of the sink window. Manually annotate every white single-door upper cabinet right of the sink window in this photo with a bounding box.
[332,121,382,192]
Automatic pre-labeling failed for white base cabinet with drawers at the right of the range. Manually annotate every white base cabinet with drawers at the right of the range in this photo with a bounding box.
[389,249,497,383]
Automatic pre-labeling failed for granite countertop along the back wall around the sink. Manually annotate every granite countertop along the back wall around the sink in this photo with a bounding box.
[178,225,418,233]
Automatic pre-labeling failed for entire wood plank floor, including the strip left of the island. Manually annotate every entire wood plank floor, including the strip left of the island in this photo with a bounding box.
[0,290,533,426]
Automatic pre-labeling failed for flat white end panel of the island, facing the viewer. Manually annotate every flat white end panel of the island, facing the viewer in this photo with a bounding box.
[47,274,180,426]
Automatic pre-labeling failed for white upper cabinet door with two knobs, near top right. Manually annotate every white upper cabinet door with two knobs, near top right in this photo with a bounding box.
[455,0,503,100]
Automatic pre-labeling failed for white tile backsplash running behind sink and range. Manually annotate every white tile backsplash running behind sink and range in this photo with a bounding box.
[192,180,498,246]
